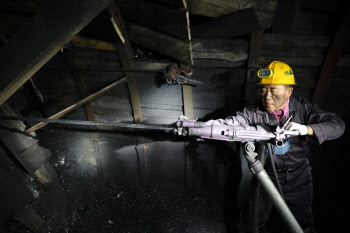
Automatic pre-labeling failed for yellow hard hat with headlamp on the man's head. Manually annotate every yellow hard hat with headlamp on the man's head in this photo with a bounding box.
[257,61,296,85]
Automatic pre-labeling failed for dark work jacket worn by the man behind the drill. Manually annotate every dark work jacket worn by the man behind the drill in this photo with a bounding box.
[225,97,345,168]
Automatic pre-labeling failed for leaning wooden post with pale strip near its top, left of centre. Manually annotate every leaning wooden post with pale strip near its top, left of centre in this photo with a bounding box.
[108,2,142,124]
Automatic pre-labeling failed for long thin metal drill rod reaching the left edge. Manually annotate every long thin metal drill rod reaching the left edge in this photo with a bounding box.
[0,116,174,131]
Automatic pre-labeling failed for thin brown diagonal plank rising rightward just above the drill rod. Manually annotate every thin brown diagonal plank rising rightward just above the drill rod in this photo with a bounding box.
[25,78,126,133]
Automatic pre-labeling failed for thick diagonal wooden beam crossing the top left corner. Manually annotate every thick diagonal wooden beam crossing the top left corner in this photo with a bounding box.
[0,0,112,105]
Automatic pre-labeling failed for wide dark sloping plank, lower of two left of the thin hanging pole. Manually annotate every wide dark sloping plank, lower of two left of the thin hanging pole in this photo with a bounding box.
[126,22,191,64]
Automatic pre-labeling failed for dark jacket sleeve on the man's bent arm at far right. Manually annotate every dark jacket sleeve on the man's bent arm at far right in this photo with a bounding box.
[306,103,345,145]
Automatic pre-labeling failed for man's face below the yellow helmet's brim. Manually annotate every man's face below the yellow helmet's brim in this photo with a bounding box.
[261,85,293,111]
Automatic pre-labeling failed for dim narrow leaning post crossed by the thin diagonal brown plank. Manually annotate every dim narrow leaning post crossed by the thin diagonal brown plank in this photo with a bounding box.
[63,52,96,121]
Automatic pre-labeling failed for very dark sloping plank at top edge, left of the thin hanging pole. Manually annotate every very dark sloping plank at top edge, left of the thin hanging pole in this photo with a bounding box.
[118,0,187,39]
